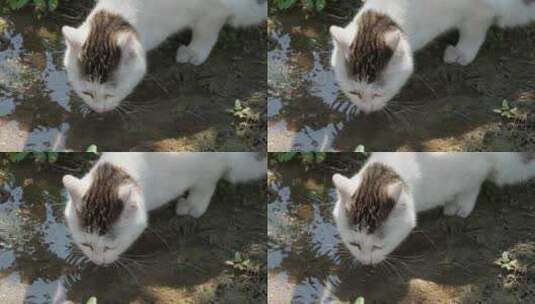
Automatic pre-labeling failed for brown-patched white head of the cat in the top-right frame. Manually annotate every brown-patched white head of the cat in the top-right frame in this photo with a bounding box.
[330,11,414,113]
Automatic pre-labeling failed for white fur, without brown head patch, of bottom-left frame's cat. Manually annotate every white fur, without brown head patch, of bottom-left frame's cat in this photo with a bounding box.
[63,152,267,265]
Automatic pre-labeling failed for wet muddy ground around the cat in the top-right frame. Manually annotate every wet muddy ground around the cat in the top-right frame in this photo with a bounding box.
[268,0,535,152]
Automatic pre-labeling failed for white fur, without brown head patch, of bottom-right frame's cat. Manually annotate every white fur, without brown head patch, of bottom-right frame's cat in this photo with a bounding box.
[333,152,535,264]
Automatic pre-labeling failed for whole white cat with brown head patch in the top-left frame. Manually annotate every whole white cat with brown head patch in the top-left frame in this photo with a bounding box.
[62,0,267,113]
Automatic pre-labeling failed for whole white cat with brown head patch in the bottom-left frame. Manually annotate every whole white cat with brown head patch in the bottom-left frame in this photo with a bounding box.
[63,152,267,265]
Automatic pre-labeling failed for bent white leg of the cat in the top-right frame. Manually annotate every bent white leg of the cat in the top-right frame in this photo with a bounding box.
[444,14,493,65]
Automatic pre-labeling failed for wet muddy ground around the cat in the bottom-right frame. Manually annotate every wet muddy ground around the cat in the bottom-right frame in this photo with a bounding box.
[268,154,535,304]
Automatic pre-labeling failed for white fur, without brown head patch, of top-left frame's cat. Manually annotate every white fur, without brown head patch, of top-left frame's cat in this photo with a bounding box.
[62,0,267,112]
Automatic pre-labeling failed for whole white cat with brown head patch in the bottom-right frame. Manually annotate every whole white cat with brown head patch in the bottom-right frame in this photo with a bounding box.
[332,152,535,264]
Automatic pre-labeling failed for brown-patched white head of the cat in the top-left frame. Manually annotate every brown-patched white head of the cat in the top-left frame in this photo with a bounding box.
[62,11,147,113]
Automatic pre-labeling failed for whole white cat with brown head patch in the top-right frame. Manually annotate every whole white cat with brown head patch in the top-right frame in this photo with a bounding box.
[330,0,535,113]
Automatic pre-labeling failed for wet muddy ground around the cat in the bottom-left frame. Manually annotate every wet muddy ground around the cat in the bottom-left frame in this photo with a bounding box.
[0,158,267,304]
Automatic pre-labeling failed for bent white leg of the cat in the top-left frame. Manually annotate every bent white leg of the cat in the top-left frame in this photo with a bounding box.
[176,15,226,65]
